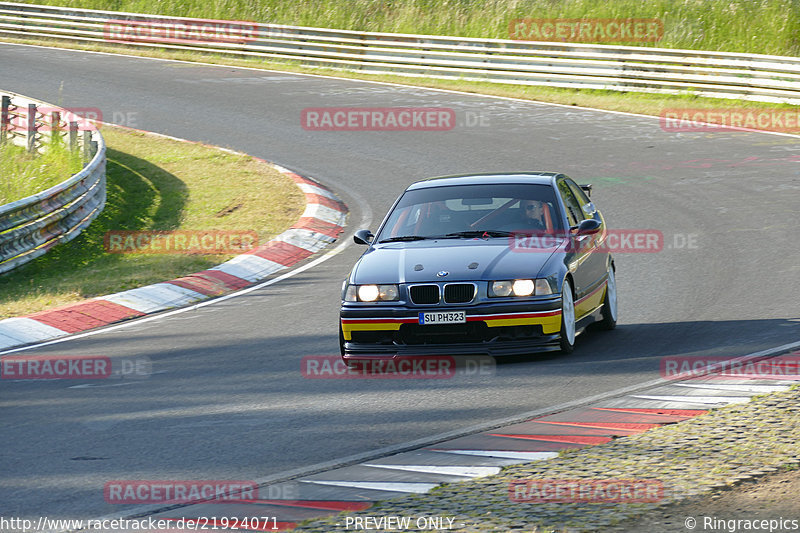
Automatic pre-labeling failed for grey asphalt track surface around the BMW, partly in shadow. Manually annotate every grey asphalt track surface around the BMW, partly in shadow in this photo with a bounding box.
[0,45,800,518]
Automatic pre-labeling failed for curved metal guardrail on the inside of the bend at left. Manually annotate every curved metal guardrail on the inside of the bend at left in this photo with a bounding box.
[0,93,106,274]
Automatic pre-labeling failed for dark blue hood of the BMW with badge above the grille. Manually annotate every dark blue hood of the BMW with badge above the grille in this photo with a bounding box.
[350,238,557,284]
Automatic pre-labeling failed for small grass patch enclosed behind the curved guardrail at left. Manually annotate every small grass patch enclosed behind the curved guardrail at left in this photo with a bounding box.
[0,143,81,205]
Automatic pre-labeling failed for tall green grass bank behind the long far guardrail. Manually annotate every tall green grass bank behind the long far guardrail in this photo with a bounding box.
[20,0,800,56]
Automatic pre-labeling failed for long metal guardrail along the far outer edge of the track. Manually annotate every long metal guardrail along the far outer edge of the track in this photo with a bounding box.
[0,2,800,104]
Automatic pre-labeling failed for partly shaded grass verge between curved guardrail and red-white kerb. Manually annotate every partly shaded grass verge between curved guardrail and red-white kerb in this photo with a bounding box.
[0,126,305,318]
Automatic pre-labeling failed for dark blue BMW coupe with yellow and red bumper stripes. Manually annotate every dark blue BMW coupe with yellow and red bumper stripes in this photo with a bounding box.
[339,172,617,360]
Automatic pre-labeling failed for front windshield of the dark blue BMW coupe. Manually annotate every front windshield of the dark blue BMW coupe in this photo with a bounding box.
[376,183,563,242]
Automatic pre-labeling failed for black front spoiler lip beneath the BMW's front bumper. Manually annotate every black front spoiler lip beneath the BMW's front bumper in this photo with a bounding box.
[342,334,560,360]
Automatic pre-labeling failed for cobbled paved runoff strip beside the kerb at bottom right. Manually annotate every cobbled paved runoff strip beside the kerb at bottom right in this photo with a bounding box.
[295,380,800,533]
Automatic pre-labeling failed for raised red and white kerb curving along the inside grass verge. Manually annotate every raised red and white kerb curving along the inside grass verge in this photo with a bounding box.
[0,161,347,349]
